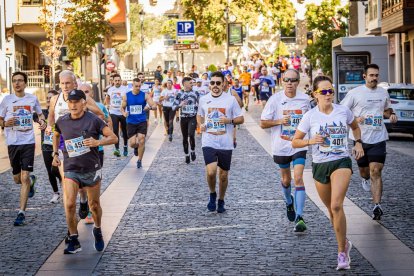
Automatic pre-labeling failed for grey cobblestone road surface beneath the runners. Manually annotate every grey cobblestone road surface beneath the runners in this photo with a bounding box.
[0,96,414,275]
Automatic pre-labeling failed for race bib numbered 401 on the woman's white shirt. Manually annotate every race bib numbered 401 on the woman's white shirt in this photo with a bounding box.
[319,126,347,154]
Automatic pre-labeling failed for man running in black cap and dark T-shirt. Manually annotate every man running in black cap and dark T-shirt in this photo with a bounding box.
[53,90,118,254]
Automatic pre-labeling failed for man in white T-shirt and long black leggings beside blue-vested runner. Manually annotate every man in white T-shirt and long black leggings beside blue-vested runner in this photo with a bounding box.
[105,74,128,157]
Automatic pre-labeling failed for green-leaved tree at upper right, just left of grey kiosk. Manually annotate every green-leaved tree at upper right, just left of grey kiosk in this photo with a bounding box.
[305,0,349,75]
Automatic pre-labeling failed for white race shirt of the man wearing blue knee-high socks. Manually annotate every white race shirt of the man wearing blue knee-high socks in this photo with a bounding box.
[261,90,311,156]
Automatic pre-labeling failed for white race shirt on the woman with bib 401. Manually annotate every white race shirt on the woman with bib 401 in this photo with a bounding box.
[297,104,354,163]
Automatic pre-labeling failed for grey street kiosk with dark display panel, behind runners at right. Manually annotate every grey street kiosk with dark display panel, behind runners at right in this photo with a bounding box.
[332,36,388,102]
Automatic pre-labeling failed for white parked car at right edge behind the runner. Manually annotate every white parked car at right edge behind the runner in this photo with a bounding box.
[378,83,414,135]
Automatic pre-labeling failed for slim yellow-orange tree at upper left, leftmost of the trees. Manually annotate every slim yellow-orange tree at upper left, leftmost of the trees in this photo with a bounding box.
[39,0,69,87]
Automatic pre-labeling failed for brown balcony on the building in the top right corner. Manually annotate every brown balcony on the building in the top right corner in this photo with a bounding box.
[381,0,414,33]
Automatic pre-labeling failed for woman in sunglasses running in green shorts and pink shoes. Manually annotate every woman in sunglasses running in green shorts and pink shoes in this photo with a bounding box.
[292,76,364,270]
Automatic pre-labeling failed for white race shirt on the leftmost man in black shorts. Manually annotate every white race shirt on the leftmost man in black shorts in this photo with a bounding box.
[0,93,42,145]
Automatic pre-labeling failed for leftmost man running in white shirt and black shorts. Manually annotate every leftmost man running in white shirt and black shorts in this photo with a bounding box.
[0,72,46,226]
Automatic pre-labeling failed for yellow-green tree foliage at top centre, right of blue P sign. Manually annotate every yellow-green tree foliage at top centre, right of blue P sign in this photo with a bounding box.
[181,0,295,45]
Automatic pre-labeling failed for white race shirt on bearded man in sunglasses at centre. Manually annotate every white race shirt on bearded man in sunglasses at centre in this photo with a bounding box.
[197,93,243,150]
